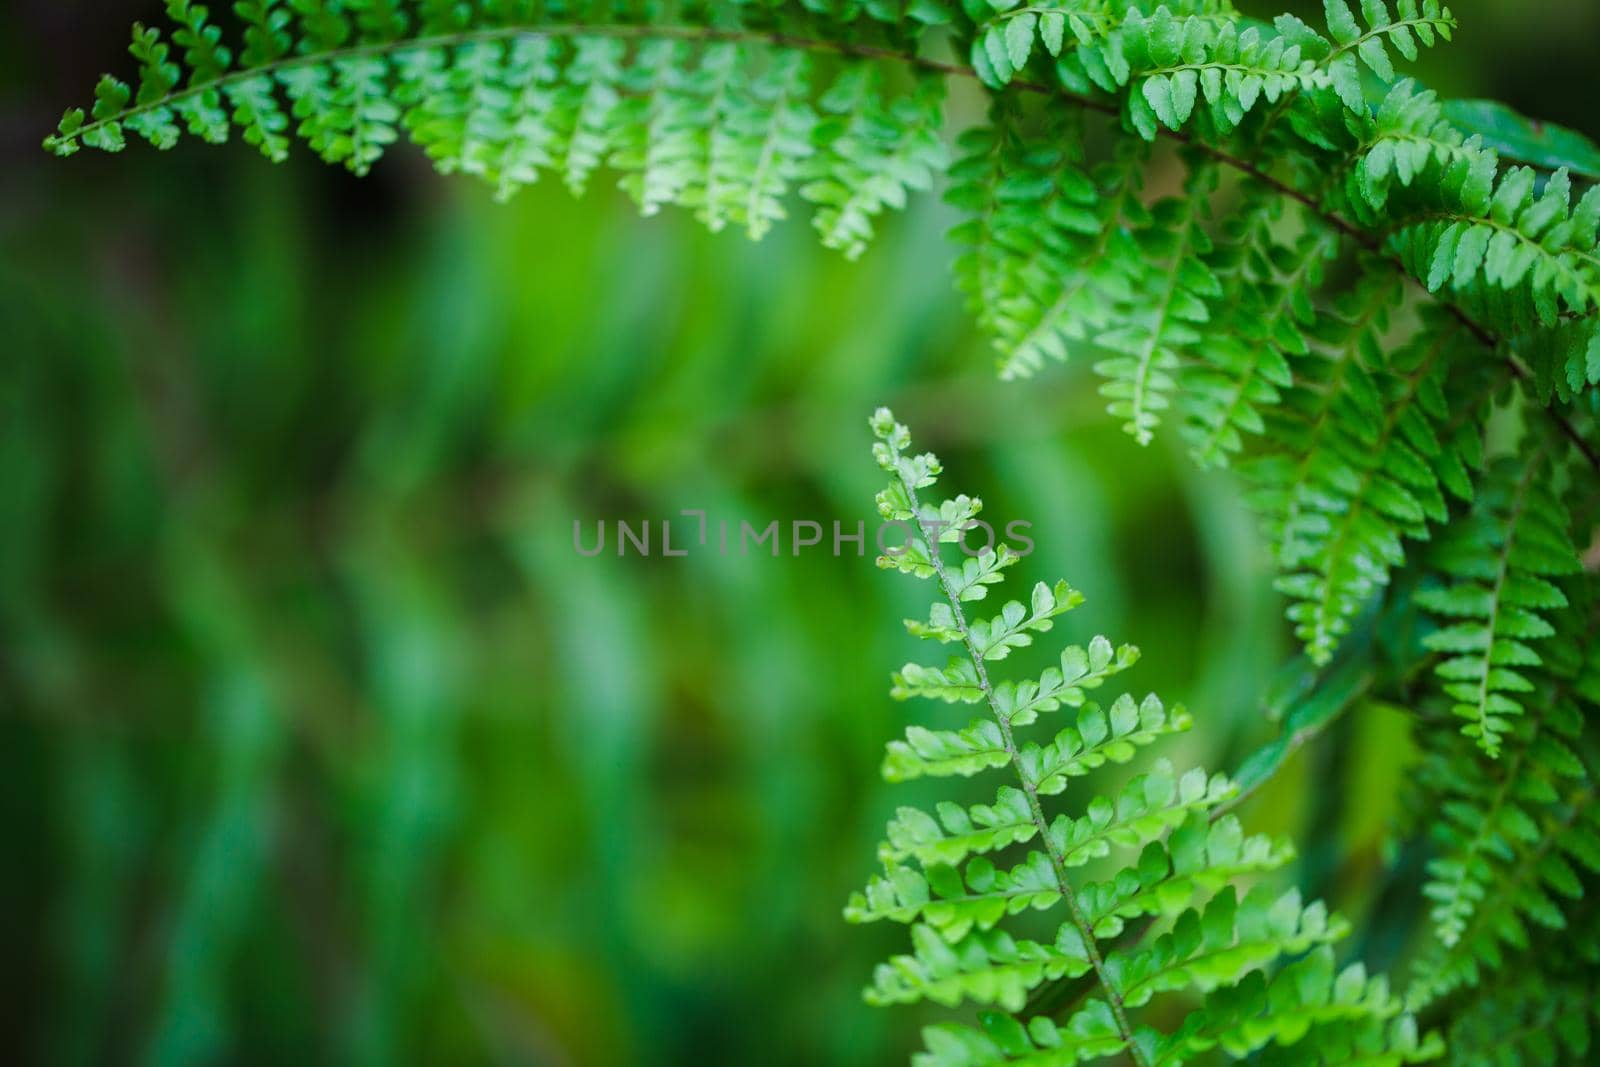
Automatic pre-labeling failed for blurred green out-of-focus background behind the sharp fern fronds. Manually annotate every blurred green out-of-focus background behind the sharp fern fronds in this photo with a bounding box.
[0,0,1600,1065]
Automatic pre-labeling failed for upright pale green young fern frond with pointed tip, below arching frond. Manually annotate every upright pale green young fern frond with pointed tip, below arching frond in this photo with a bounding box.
[845,410,1438,1067]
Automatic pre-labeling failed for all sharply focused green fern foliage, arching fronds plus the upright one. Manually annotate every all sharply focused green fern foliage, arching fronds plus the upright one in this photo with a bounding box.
[46,0,1600,1064]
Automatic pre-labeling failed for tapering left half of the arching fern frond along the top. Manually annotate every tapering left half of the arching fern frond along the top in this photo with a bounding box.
[46,0,949,247]
